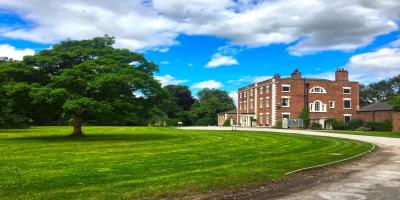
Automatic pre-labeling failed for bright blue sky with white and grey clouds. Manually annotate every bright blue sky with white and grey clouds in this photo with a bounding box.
[0,0,400,99]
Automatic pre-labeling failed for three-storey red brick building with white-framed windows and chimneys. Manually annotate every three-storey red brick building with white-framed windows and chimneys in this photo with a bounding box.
[237,69,359,128]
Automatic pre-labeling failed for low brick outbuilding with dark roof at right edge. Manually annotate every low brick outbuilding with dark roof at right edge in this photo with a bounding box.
[356,102,400,131]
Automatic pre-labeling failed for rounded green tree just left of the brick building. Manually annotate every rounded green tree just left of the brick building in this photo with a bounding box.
[191,89,235,125]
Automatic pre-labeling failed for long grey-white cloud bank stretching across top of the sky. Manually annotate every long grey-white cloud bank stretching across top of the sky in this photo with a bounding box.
[0,0,400,55]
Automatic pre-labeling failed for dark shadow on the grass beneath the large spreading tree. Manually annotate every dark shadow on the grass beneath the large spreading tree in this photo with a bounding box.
[4,134,178,142]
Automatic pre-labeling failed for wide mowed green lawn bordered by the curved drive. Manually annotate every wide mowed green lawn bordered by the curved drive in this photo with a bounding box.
[0,127,372,199]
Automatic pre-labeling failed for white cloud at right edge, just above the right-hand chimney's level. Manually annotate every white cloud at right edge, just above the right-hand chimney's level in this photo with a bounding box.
[346,48,400,83]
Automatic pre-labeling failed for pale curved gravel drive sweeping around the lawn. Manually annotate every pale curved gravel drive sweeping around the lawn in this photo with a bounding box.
[182,127,400,200]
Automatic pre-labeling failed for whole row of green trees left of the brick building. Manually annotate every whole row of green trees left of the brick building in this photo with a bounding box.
[0,36,234,136]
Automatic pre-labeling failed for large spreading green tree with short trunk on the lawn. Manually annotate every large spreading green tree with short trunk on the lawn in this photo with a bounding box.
[0,36,165,136]
